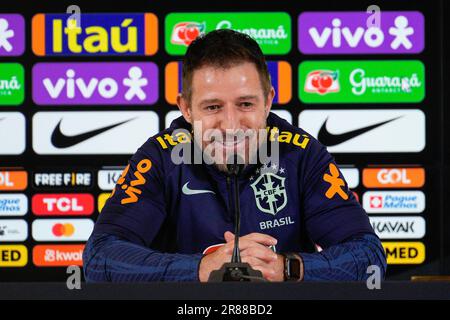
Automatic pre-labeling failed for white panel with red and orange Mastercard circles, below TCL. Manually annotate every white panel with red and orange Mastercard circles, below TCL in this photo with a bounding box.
[31,219,94,241]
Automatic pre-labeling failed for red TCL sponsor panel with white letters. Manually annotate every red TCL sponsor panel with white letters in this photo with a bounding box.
[32,193,94,216]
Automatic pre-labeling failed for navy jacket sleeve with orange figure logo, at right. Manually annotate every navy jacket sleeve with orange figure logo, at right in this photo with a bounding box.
[299,139,386,281]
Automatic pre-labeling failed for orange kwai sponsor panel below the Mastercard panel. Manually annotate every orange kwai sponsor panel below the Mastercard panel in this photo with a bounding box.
[33,244,84,267]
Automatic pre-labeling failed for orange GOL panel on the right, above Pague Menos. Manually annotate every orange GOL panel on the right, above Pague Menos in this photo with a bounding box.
[363,168,425,188]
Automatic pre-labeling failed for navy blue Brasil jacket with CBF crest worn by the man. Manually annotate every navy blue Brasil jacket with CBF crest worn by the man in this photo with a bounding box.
[83,113,386,281]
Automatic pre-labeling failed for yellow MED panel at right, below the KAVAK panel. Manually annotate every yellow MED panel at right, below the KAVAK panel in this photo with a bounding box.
[382,242,425,264]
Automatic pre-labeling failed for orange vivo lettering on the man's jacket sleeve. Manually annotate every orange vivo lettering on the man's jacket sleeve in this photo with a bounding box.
[113,159,152,204]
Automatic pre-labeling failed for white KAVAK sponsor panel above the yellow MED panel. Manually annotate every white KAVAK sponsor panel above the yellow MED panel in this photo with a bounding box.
[369,216,425,239]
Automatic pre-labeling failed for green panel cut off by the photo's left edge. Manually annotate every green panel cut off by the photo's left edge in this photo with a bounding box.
[0,63,25,106]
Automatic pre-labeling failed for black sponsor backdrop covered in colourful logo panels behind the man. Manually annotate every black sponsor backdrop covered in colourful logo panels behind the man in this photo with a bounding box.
[0,1,448,281]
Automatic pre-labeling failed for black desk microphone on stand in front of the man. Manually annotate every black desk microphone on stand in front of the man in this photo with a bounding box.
[208,155,266,282]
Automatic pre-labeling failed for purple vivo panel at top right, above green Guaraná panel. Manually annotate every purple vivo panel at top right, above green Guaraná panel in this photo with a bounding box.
[298,11,425,54]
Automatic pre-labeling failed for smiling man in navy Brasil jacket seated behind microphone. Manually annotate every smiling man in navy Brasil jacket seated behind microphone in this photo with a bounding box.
[83,30,386,282]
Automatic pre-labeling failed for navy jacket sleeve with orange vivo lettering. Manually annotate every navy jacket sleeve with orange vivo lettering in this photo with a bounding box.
[83,140,201,282]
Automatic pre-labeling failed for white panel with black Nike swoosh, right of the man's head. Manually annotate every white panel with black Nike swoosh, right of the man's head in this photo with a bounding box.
[299,109,425,153]
